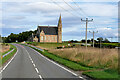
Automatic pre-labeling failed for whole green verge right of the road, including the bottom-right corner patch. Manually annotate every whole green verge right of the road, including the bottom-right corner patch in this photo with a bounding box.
[23,46,120,80]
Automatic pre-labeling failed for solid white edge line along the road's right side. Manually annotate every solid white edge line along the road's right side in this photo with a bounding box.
[31,45,86,80]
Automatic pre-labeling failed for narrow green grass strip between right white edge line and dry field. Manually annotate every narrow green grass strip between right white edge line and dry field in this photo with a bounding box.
[22,45,96,71]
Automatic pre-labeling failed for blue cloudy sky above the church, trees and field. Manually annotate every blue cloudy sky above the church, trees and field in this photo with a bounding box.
[0,0,119,41]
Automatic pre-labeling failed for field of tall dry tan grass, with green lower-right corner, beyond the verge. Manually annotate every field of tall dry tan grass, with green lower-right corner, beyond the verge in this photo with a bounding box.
[26,43,118,78]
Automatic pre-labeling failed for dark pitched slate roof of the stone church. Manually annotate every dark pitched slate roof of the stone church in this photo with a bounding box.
[38,26,58,35]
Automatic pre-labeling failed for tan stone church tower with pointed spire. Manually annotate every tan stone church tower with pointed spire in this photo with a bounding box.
[57,14,62,43]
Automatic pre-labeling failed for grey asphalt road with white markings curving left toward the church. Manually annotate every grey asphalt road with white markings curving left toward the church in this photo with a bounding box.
[1,44,83,80]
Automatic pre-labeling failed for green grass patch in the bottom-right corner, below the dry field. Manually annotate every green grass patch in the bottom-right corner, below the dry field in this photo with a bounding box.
[83,69,120,80]
